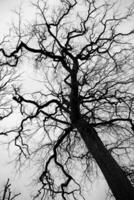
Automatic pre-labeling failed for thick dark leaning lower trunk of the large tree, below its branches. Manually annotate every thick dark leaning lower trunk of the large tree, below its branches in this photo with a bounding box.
[75,119,134,200]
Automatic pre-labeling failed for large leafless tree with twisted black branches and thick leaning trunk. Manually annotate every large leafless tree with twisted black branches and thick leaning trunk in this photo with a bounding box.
[0,0,134,200]
